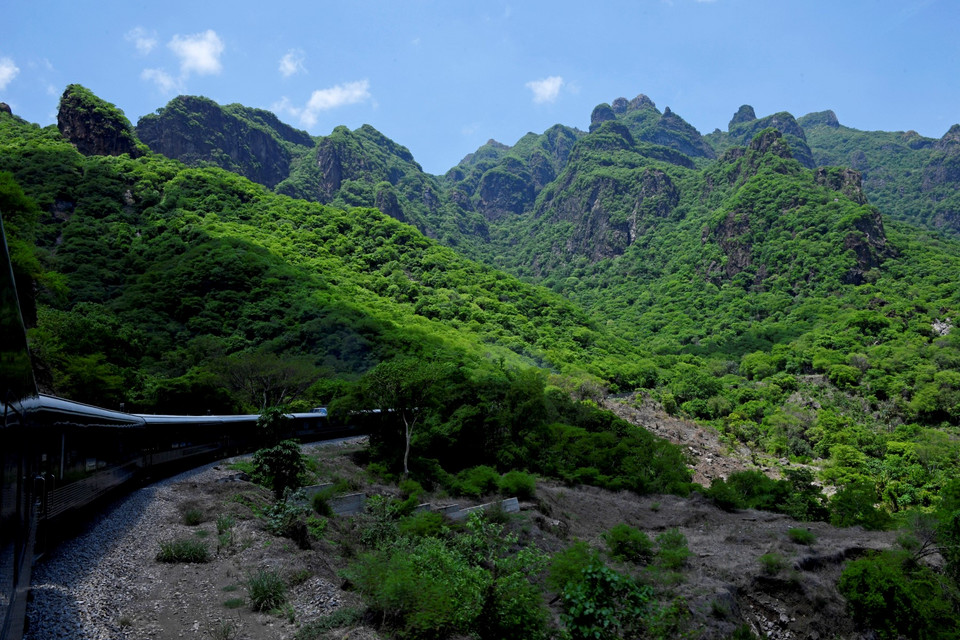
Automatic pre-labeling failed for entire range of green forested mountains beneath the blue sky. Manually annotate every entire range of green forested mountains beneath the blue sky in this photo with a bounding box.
[0,88,960,510]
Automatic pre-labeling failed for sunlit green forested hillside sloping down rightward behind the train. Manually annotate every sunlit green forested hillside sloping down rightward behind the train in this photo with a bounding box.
[0,89,638,410]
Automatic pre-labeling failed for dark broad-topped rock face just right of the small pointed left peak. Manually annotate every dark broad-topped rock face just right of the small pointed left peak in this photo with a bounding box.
[137,96,313,188]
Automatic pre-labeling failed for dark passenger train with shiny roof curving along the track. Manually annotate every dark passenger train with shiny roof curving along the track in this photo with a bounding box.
[0,219,356,640]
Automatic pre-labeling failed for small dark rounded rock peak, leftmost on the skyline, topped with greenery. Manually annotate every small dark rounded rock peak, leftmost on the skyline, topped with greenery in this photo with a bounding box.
[57,84,143,158]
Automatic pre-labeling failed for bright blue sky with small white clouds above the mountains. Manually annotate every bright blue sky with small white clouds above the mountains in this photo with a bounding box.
[0,0,960,173]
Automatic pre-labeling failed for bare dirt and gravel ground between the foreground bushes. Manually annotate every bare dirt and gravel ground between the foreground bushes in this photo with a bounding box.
[28,436,893,640]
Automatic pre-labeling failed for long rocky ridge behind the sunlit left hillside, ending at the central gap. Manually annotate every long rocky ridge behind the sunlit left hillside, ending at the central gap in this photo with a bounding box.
[136,96,486,254]
